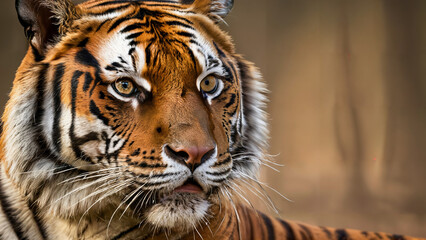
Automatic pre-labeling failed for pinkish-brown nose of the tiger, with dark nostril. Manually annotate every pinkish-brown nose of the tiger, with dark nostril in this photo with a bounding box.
[164,145,216,172]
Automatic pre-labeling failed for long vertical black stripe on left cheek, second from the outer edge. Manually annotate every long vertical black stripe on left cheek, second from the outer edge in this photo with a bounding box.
[52,63,65,154]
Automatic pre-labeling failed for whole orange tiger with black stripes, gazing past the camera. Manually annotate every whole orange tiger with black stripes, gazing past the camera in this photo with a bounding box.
[0,0,424,240]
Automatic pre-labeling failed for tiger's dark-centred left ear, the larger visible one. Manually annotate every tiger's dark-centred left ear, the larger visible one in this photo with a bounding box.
[15,0,78,55]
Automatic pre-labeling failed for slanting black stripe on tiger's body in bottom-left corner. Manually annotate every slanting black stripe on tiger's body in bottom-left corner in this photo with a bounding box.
[0,177,29,240]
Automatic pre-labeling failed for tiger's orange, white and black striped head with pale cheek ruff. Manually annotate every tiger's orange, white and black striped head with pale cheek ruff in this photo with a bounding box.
[5,0,267,232]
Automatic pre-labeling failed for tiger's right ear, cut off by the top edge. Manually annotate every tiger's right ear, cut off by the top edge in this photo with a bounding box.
[188,0,234,20]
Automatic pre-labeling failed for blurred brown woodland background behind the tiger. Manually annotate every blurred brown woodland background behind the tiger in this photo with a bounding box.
[0,0,426,237]
